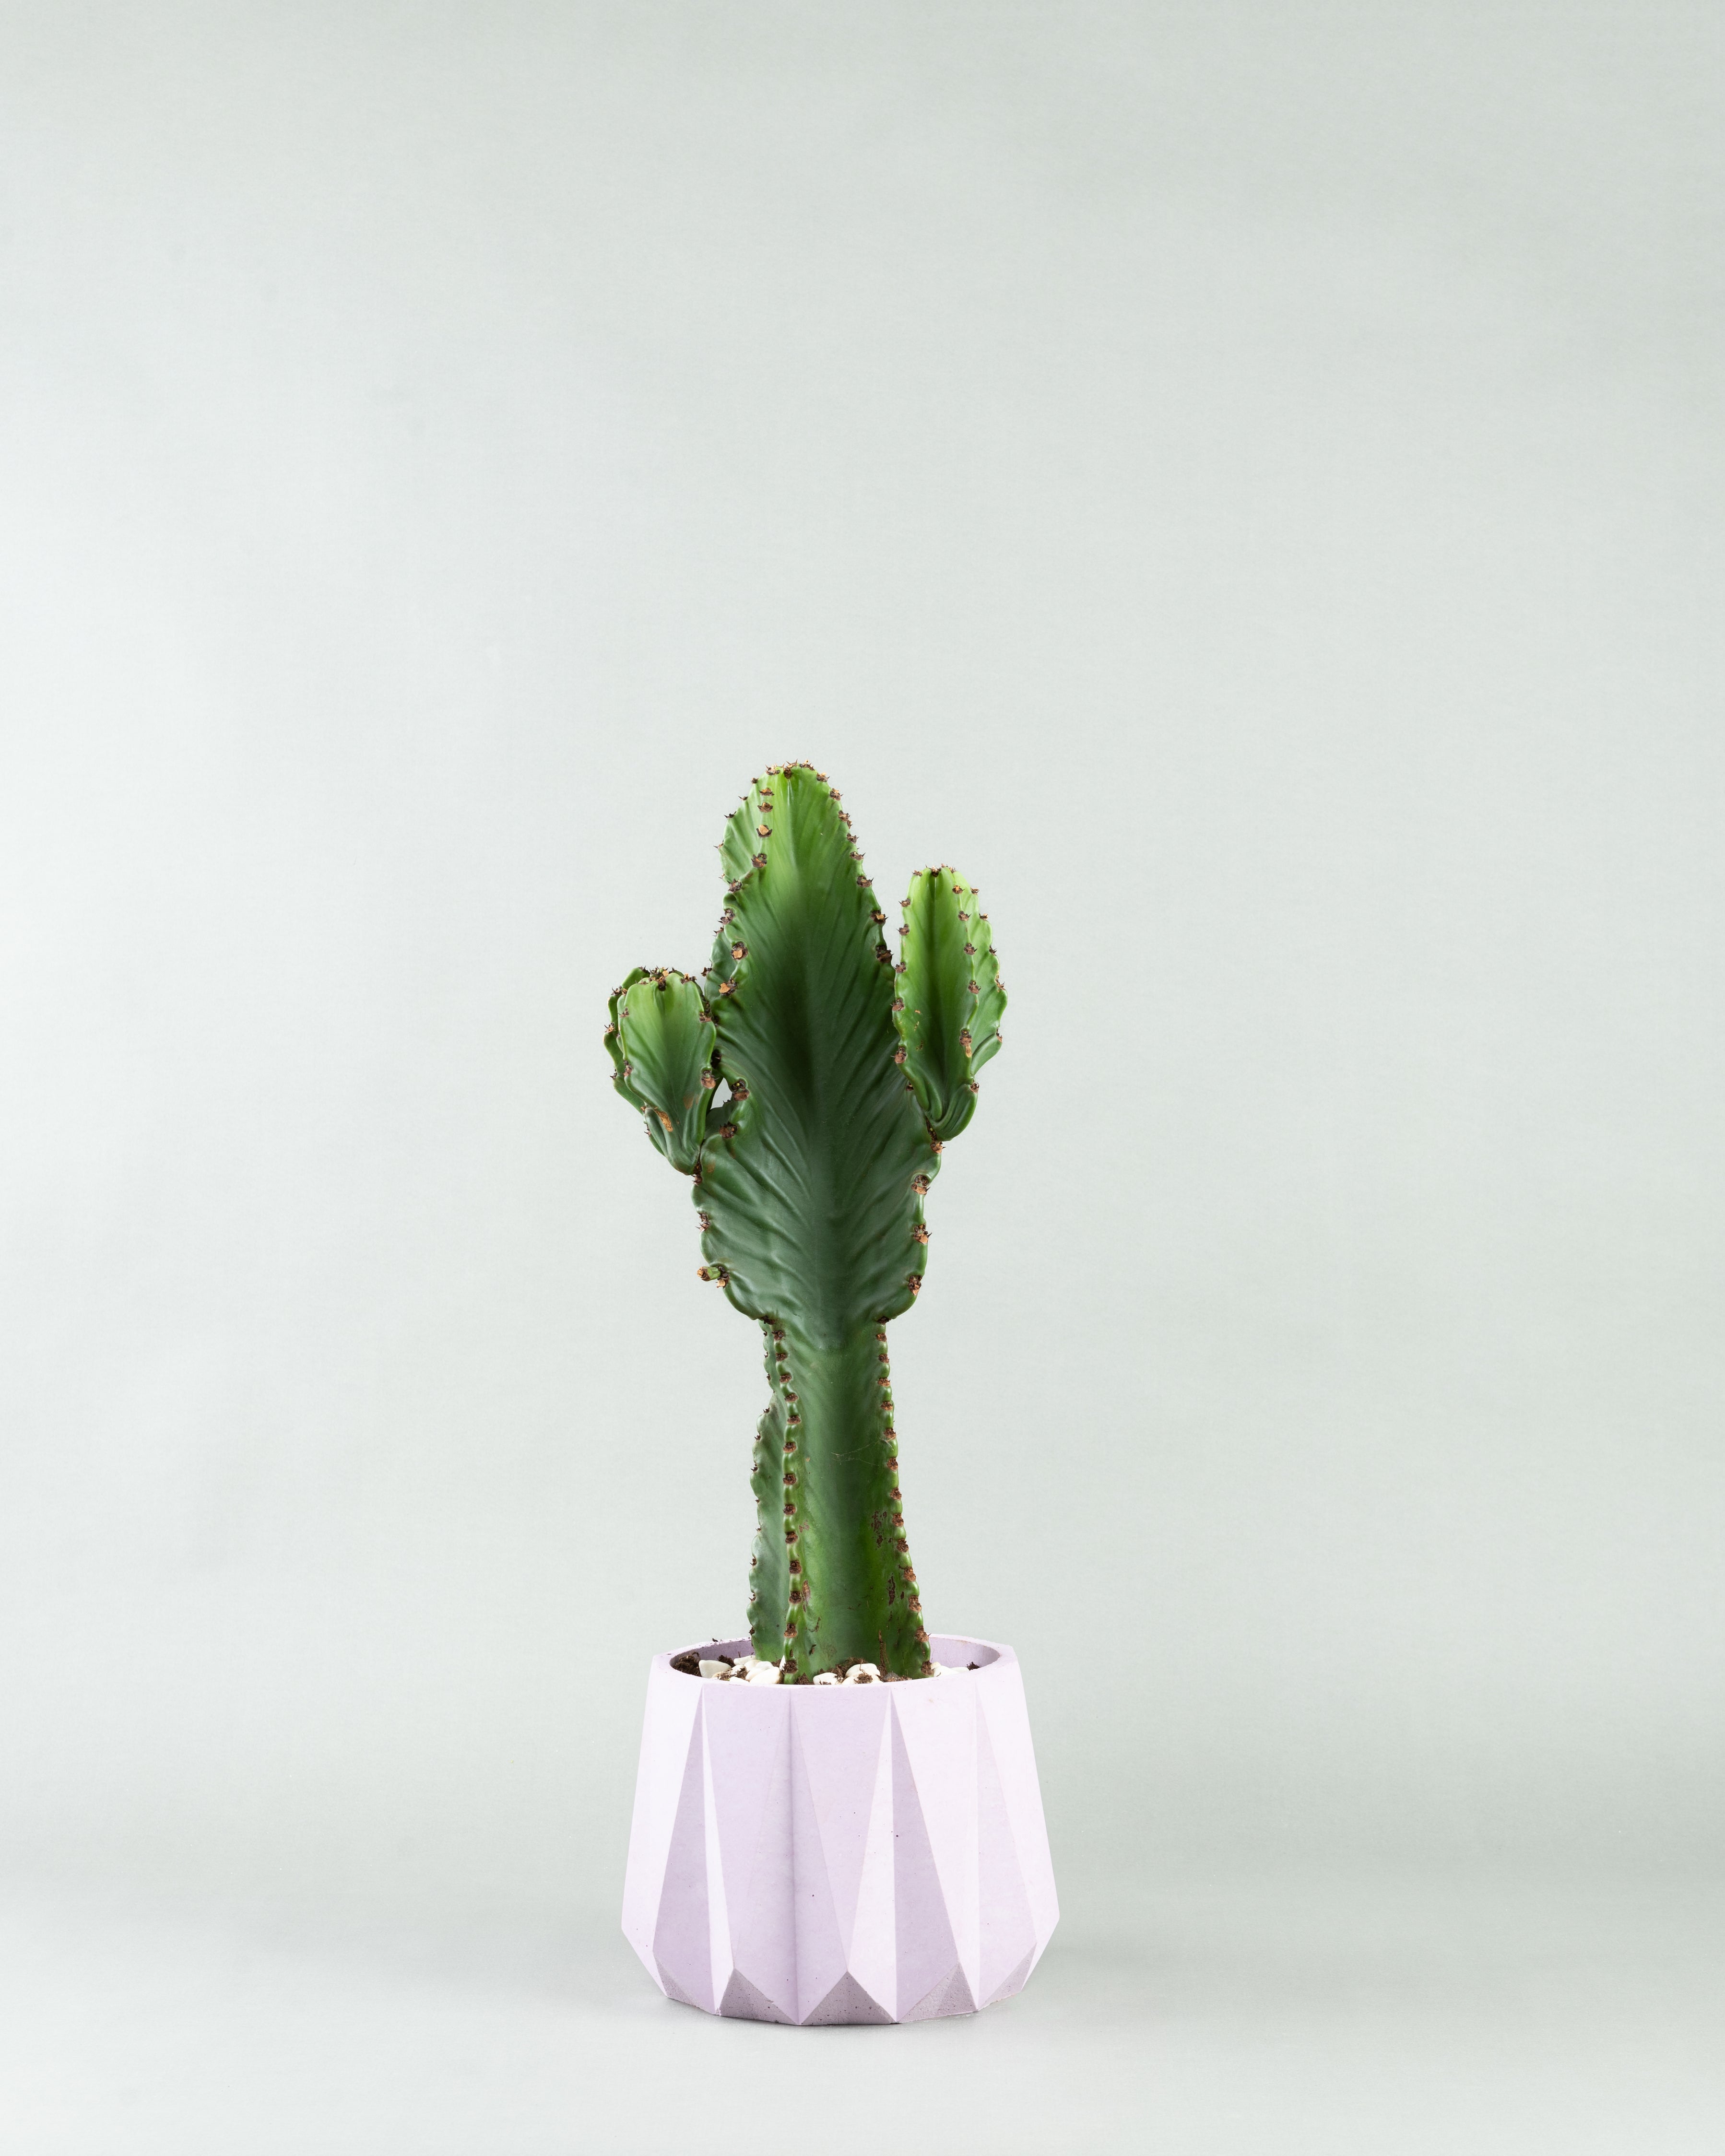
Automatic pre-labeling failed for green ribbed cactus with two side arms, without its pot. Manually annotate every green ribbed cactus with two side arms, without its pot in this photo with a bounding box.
[606,763,1007,1684]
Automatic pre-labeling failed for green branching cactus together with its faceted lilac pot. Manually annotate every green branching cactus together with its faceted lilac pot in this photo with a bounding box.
[606,763,1059,2025]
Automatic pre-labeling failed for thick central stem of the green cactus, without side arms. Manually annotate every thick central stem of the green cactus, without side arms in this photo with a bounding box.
[697,766,936,1675]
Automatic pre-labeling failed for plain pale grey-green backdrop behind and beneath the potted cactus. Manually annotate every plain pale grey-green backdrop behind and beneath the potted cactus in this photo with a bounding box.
[0,0,1725,2156]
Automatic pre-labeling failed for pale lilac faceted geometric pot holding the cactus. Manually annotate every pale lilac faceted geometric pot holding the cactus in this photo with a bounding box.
[623,1637,1059,2025]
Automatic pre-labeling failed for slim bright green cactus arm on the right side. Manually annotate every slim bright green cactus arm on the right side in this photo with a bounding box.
[893,867,1007,1143]
